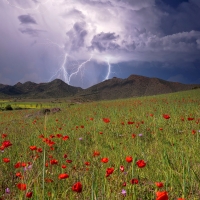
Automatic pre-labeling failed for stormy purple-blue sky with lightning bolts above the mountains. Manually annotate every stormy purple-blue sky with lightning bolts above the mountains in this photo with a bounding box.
[0,0,200,88]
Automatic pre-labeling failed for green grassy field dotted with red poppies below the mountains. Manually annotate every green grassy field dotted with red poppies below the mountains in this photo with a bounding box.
[0,89,200,200]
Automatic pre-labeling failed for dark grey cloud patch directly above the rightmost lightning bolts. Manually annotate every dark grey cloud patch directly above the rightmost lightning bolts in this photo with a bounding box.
[89,32,120,52]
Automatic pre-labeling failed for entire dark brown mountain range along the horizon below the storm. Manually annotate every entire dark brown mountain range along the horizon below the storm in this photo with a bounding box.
[0,75,200,101]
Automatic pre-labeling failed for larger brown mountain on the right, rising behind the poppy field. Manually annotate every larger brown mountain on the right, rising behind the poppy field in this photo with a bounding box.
[79,75,200,100]
